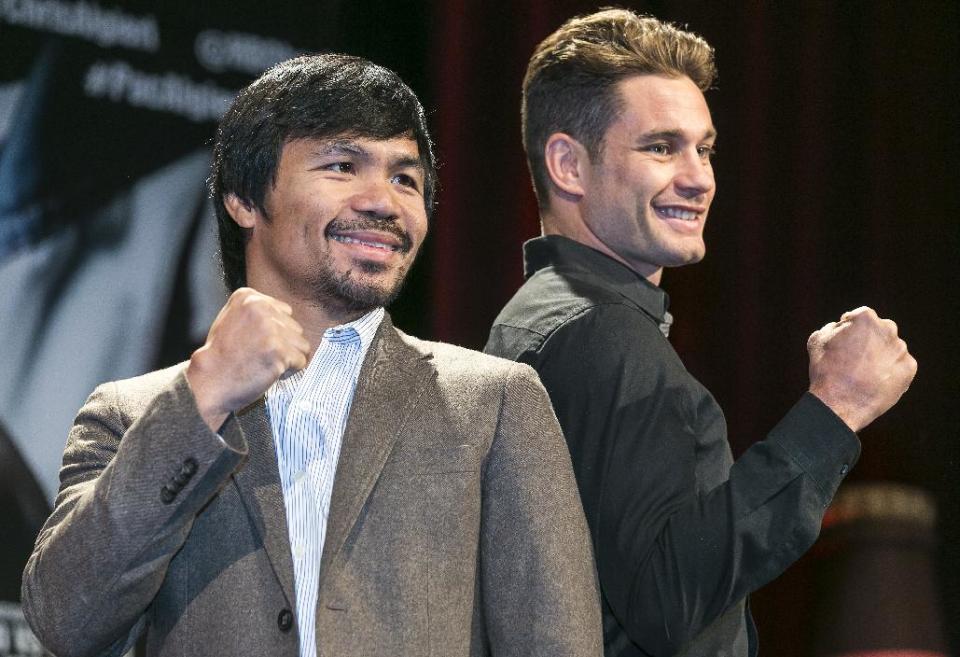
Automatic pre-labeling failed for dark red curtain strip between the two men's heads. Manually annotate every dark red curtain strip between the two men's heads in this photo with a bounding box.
[431,2,557,348]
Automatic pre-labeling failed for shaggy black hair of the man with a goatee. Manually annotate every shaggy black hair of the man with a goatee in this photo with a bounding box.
[210,55,436,294]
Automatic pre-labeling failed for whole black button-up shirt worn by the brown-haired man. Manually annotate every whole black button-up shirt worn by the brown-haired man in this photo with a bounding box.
[485,236,860,657]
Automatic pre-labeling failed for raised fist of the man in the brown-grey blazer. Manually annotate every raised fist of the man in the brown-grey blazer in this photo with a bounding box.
[186,287,311,431]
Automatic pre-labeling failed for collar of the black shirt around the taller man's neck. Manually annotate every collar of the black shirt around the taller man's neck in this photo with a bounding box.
[523,235,673,335]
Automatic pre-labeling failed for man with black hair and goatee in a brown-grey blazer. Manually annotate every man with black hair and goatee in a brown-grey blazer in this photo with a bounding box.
[23,55,600,657]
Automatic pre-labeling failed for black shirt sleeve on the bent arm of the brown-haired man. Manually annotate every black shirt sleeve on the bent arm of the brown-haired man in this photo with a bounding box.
[521,305,859,655]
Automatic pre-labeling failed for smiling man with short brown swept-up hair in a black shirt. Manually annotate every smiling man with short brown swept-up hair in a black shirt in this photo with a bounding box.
[486,10,916,657]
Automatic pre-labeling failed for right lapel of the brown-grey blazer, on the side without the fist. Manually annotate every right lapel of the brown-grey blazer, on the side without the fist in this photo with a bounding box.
[320,315,436,587]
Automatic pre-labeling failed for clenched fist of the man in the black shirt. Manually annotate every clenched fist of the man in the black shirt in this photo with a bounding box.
[807,307,917,431]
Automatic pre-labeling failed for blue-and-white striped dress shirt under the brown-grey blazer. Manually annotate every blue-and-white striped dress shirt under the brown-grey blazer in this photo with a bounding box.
[266,308,384,657]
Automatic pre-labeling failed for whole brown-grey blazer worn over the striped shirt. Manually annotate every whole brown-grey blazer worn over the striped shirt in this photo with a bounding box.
[23,318,602,657]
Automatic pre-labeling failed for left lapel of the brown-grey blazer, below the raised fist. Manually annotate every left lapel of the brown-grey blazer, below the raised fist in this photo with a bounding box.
[234,399,296,605]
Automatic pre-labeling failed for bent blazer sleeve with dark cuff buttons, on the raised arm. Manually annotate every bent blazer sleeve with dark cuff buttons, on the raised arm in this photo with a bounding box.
[22,372,246,657]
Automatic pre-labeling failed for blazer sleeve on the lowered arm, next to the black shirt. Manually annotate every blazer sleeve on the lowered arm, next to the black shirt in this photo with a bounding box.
[480,365,603,657]
